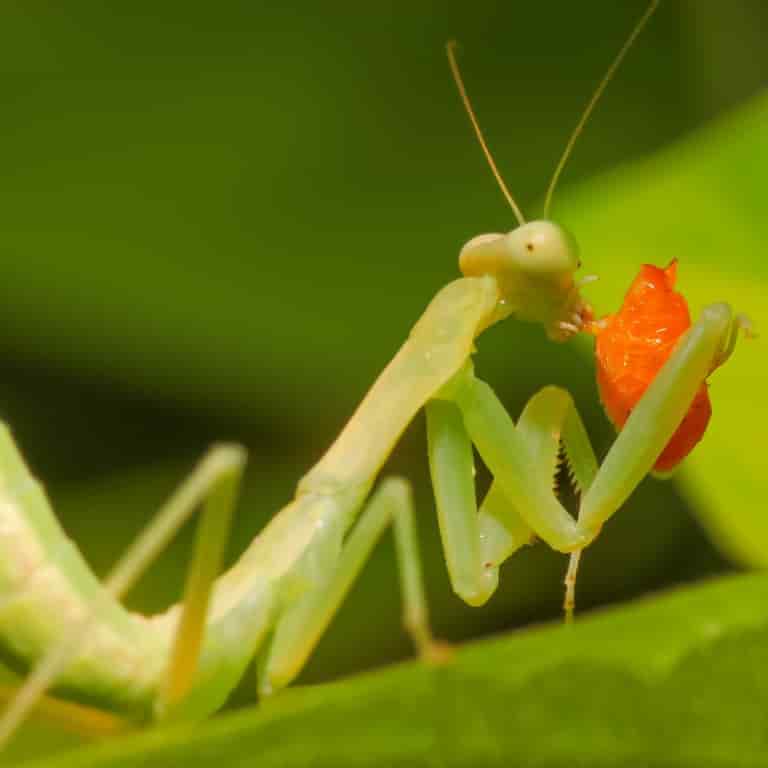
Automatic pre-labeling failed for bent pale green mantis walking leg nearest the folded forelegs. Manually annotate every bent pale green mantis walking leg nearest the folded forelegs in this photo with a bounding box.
[259,478,444,696]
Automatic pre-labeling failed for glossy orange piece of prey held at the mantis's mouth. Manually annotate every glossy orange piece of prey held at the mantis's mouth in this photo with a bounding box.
[591,260,712,472]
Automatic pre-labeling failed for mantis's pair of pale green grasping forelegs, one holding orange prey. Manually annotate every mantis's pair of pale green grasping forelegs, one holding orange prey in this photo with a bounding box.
[428,304,744,612]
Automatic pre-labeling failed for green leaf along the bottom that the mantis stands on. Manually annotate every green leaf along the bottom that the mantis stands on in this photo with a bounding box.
[16,574,768,768]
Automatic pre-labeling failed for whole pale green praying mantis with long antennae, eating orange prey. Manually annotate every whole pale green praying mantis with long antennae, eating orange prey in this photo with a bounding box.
[0,0,743,756]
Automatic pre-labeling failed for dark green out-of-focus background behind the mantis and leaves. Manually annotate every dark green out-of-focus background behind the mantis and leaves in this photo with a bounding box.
[0,0,768,708]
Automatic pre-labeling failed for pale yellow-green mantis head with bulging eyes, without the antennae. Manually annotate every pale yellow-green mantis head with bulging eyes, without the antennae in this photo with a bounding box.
[459,220,593,341]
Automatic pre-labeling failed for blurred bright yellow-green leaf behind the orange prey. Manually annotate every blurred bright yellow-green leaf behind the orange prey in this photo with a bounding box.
[555,97,768,567]
